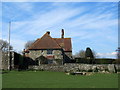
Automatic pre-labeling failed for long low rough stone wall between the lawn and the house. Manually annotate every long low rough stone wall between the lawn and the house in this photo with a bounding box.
[28,63,120,72]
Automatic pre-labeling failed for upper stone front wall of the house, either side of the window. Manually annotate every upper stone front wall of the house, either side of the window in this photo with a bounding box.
[28,50,63,60]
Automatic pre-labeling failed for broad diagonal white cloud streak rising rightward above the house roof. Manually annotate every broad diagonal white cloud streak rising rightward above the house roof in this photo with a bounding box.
[10,5,83,35]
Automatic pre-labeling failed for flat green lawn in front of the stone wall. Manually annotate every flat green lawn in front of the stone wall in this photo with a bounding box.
[2,71,118,88]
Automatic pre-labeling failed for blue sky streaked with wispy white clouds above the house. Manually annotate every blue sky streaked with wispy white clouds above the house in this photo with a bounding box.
[2,2,118,58]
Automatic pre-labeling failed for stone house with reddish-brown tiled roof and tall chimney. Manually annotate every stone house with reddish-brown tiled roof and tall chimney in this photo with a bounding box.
[25,29,72,63]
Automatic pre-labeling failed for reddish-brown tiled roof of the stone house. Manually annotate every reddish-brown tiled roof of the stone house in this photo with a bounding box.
[28,33,72,51]
